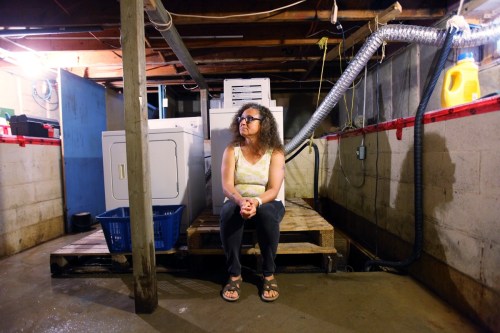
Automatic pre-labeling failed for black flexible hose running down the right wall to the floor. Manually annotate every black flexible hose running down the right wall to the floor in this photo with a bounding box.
[365,27,456,271]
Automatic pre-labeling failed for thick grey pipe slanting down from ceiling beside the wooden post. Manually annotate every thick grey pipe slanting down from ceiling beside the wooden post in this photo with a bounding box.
[144,0,208,90]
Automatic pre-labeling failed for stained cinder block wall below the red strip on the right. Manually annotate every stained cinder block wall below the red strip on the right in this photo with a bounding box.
[323,112,500,327]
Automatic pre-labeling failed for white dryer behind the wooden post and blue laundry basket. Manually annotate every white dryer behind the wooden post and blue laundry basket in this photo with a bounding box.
[102,117,206,232]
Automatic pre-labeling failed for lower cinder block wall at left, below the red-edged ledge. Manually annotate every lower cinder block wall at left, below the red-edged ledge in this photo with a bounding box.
[0,144,64,257]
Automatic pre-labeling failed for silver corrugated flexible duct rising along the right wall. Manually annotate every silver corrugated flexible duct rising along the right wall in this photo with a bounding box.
[285,23,500,154]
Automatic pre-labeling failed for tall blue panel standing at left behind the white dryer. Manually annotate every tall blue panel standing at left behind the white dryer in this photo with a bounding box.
[60,70,106,233]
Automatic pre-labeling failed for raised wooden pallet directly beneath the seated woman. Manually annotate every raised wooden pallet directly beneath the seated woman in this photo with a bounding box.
[187,199,337,271]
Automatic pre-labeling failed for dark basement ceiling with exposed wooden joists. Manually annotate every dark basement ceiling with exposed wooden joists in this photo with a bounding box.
[0,0,485,98]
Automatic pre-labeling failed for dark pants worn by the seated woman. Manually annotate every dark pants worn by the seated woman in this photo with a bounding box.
[220,200,285,276]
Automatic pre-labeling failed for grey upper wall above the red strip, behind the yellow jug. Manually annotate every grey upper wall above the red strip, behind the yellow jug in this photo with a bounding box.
[340,44,500,133]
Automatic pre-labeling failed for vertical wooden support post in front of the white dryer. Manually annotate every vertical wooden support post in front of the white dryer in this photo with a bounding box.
[120,0,158,313]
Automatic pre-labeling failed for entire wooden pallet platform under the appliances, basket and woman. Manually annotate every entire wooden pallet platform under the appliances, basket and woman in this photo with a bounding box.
[50,199,337,275]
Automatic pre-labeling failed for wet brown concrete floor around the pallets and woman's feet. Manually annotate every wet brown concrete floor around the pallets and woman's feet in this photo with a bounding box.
[0,234,480,333]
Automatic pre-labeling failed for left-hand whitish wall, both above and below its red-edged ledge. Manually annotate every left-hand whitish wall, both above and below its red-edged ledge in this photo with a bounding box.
[0,71,64,257]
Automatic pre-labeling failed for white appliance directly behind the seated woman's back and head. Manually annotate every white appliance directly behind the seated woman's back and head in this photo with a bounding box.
[210,106,285,215]
